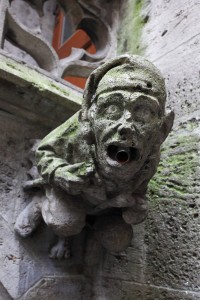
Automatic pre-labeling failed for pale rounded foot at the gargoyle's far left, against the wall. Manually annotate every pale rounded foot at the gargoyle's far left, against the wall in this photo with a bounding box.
[14,195,42,237]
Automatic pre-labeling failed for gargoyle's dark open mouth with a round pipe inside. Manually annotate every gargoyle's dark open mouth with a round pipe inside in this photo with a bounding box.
[107,145,140,164]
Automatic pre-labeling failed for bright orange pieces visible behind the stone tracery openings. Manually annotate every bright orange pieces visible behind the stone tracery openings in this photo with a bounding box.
[52,10,96,89]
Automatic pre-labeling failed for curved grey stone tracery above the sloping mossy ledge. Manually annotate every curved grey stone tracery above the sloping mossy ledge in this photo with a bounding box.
[0,0,122,87]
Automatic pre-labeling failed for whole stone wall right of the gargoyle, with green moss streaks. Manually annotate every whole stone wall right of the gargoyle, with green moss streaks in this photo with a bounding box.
[112,0,200,300]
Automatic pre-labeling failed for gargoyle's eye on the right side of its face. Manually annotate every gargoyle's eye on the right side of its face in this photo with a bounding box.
[133,106,157,123]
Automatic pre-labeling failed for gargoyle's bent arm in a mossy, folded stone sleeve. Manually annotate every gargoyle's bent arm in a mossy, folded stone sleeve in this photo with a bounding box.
[36,114,93,194]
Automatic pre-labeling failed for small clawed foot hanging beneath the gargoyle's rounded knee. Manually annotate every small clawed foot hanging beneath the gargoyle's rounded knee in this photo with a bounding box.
[49,237,71,259]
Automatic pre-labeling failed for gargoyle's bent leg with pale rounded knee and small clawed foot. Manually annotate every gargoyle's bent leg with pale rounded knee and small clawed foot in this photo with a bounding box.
[42,187,86,258]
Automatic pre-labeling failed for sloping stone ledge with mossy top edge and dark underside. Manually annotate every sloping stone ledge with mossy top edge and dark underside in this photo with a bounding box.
[0,51,82,128]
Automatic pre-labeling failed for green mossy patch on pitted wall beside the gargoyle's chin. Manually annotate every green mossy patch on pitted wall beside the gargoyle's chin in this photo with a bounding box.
[149,135,199,201]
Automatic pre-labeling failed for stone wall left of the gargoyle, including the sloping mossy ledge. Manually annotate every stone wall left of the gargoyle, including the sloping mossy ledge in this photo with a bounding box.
[0,54,84,300]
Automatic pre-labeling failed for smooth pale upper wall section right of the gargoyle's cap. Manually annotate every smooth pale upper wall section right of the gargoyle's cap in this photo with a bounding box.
[143,0,200,118]
